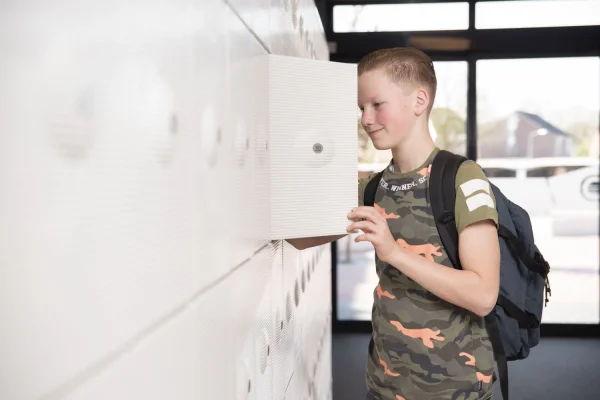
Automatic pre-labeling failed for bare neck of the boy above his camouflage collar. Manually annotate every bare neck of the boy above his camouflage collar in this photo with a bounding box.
[392,123,436,173]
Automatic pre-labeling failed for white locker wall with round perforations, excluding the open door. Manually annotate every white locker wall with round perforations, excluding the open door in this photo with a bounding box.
[0,0,356,400]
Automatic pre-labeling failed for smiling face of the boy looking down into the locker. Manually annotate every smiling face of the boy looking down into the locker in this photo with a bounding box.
[358,69,417,150]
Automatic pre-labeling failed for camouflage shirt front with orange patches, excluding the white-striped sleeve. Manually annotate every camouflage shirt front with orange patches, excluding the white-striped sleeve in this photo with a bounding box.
[359,149,494,400]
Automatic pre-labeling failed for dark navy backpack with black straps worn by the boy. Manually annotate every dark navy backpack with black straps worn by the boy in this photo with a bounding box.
[364,150,551,400]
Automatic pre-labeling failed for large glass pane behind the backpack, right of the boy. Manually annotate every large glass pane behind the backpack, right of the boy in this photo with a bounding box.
[477,57,600,324]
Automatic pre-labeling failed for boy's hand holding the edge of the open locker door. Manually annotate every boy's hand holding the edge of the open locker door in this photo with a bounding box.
[346,207,400,262]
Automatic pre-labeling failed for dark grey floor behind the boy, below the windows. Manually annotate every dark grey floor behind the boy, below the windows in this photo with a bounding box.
[333,334,600,400]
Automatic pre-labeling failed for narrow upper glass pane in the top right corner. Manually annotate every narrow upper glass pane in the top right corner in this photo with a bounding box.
[475,0,600,29]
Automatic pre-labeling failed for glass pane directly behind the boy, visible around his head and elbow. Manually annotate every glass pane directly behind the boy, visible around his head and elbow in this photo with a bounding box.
[337,61,467,320]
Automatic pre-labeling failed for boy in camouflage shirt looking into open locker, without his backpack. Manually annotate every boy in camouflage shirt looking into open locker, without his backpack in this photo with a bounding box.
[288,48,500,400]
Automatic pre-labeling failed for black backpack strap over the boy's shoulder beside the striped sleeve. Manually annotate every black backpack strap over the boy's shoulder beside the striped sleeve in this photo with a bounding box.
[429,150,467,269]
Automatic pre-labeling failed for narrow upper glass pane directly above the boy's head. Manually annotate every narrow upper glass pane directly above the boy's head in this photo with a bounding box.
[333,2,469,33]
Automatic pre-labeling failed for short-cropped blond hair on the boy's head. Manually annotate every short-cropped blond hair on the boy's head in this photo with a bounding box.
[358,47,437,114]
